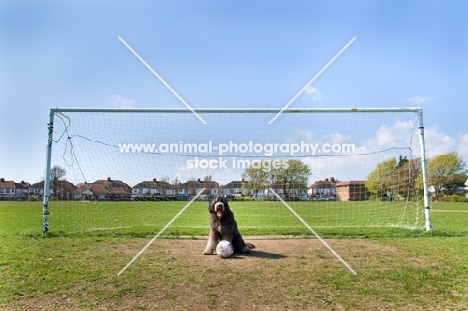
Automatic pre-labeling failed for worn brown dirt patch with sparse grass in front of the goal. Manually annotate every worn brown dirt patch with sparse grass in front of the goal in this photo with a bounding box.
[109,237,406,310]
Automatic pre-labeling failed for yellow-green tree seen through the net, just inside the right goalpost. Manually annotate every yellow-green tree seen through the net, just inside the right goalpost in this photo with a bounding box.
[366,158,397,198]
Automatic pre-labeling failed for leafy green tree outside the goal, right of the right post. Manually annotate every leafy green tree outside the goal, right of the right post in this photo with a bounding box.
[427,152,468,200]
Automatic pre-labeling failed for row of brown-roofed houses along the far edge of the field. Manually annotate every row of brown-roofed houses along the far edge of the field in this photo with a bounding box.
[0,177,369,201]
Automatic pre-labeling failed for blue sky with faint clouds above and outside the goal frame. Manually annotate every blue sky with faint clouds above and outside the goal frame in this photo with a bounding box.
[0,0,468,183]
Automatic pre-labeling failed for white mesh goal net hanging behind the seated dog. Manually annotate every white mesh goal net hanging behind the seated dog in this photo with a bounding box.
[43,108,429,236]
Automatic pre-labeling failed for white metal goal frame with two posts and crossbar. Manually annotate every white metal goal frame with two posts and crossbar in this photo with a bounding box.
[42,107,432,235]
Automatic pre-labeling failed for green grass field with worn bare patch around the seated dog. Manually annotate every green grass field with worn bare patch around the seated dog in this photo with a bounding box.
[0,202,468,310]
